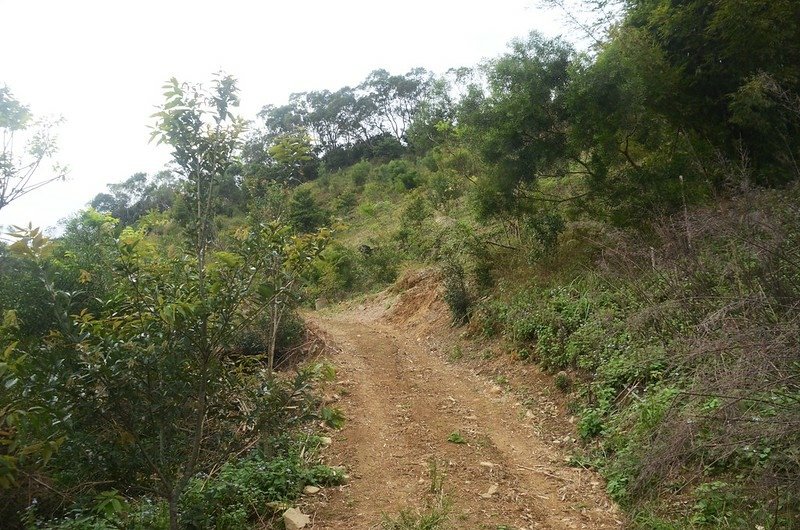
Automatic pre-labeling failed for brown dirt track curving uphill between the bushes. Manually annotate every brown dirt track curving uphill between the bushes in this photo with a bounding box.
[307,300,622,530]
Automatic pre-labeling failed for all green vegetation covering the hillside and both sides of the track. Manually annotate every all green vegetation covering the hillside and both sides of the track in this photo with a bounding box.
[0,0,800,528]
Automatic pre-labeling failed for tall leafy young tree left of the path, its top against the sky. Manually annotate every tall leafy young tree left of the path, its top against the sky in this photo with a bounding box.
[0,77,329,529]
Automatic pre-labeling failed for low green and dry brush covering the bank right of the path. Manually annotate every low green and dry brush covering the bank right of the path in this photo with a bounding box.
[473,187,800,527]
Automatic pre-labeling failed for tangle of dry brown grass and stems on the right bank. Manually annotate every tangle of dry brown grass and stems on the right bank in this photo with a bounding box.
[588,186,800,521]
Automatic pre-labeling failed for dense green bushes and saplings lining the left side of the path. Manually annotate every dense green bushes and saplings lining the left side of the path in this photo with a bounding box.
[0,76,341,530]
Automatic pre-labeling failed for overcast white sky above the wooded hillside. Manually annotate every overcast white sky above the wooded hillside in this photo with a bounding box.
[0,0,566,231]
